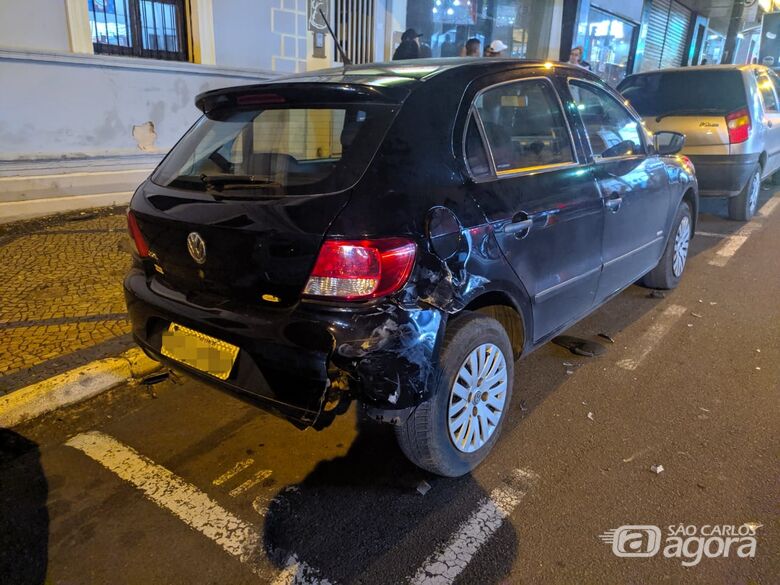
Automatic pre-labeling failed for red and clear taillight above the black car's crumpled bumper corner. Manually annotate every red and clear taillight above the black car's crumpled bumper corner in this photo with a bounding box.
[303,238,417,301]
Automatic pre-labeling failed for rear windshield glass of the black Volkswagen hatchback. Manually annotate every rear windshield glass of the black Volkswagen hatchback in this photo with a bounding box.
[152,104,395,197]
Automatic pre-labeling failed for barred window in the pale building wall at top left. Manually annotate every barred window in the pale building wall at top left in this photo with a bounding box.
[87,0,188,61]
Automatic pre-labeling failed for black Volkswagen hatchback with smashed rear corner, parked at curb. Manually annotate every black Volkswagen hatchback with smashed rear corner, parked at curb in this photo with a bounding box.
[124,59,698,476]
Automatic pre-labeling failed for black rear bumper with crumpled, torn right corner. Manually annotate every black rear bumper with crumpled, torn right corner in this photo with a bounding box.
[124,268,446,428]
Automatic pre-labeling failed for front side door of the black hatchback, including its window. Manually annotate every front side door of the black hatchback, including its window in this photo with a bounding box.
[569,79,671,301]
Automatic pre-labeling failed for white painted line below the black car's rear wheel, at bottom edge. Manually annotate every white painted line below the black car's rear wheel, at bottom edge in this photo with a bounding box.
[410,469,538,585]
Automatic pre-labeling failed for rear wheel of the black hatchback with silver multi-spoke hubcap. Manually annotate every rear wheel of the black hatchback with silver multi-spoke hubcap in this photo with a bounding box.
[396,312,514,477]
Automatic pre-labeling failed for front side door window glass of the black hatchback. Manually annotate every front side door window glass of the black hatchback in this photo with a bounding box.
[569,81,645,158]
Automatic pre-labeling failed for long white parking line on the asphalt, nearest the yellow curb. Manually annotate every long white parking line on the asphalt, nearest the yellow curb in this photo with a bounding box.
[66,431,276,582]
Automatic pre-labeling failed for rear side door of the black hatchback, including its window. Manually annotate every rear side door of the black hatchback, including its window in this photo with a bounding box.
[467,77,604,341]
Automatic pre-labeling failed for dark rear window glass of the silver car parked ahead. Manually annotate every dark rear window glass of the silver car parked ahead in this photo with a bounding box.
[618,71,746,116]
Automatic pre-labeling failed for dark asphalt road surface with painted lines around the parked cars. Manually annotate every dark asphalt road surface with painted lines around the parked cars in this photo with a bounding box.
[0,191,780,585]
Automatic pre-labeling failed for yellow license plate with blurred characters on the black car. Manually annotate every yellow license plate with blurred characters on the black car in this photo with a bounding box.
[161,323,238,380]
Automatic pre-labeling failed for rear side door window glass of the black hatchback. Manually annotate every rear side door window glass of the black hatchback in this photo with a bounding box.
[474,79,574,175]
